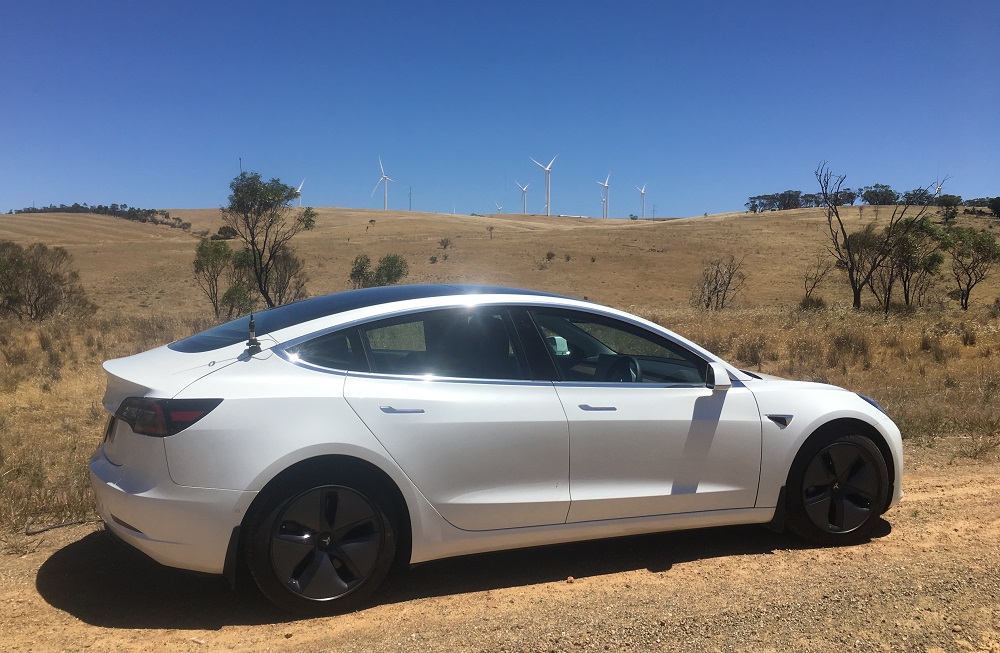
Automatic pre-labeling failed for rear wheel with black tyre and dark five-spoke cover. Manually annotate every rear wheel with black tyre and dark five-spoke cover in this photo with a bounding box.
[245,476,398,616]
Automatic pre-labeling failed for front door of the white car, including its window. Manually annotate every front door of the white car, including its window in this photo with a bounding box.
[531,309,761,522]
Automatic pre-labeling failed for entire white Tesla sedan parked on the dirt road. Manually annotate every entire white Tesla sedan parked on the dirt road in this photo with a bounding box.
[90,285,902,614]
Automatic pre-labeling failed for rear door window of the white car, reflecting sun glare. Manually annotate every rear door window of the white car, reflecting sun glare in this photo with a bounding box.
[360,308,525,379]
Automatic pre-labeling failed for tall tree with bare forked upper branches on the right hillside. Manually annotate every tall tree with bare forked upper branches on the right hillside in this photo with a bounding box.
[815,167,927,309]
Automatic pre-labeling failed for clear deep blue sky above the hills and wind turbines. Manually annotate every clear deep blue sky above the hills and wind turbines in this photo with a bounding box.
[0,0,1000,217]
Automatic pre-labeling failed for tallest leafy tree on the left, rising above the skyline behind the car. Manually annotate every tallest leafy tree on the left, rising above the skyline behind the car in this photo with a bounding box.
[221,172,316,308]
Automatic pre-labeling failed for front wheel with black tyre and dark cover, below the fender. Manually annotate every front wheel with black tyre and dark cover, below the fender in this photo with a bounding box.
[786,434,889,545]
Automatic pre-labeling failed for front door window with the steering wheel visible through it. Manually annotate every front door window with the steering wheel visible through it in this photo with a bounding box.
[531,309,707,385]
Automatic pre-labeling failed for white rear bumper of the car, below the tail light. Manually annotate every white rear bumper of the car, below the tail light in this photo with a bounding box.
[89,446,255,574]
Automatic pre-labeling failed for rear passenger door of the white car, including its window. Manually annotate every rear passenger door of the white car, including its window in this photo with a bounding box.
[344,308,569,530]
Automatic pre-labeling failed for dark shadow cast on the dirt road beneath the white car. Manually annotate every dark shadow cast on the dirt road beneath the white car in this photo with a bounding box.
[36,520,891,630]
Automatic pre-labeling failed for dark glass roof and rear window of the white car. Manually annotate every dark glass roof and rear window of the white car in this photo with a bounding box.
[169,284,569,353]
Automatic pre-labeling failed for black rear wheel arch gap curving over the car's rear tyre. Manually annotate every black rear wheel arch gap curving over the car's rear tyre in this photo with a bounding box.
[224,454,413,585]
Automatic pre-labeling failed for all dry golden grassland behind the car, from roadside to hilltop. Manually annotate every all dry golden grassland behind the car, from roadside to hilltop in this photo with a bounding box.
[0,207,1000,549]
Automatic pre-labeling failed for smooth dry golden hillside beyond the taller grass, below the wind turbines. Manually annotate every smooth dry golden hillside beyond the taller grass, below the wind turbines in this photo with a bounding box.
[0,207,1000,316]
